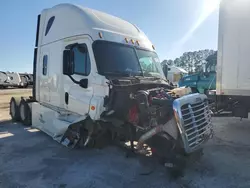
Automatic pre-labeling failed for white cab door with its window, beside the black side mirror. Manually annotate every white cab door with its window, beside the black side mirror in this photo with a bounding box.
[64,40,93,115]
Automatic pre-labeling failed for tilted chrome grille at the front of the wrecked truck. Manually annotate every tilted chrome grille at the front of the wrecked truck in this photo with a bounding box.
[174,94,212,153]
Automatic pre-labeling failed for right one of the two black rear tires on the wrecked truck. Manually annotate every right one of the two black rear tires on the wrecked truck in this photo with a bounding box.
[19,98,31,126]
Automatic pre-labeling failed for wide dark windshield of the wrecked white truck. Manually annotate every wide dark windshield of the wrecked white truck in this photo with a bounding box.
[93,41,164,78]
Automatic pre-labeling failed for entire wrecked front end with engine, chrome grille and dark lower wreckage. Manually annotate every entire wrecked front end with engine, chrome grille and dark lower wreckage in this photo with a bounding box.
[62,77,212,176]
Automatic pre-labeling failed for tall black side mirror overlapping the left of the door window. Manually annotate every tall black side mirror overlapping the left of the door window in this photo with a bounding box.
[63,50,75,76]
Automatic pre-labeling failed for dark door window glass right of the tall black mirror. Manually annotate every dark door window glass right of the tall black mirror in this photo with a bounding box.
[72,44,90,76]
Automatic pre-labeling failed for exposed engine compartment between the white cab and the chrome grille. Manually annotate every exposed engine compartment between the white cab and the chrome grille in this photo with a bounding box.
[101,78,174,130]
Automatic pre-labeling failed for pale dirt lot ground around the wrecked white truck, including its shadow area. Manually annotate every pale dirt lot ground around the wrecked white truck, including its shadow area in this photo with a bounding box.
[0,89,250,188]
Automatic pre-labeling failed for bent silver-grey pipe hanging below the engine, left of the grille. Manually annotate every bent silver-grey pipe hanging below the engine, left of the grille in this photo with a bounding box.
[136,125,163,153]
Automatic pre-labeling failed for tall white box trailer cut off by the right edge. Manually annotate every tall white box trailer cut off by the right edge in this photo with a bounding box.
[210,0,250,118]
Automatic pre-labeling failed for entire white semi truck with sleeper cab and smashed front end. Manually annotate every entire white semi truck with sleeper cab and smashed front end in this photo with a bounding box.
[10,4,212,176]
